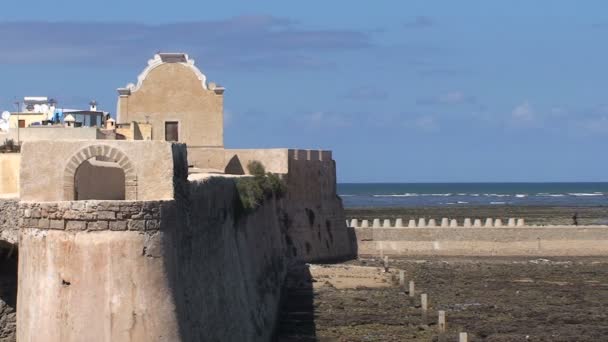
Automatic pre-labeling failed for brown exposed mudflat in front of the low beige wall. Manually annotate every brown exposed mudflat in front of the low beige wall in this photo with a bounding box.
[278,258,608,342]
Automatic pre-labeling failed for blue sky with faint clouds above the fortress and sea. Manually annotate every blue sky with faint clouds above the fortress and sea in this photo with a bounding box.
[0,0,608,182]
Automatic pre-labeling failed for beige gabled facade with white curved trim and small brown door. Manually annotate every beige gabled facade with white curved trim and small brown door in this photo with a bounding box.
[117,53,224,149]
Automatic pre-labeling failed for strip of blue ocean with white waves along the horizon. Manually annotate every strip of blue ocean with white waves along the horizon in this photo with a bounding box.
[338,182,608,208]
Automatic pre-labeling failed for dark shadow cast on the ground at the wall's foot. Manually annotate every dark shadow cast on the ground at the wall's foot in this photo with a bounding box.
[274,264,317,342]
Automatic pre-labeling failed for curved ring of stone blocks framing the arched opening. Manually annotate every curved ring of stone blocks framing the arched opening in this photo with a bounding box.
[63,145,137,201]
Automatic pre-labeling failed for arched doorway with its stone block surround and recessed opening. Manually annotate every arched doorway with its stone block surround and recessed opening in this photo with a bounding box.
[63,145,137,201]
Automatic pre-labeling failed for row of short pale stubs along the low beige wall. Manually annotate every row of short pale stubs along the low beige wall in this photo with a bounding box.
[346,217,526,228]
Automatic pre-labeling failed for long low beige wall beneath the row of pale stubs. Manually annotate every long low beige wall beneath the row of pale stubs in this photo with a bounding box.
[355,226,608,256]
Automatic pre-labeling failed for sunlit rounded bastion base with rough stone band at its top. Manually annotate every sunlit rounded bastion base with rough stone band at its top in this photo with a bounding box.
[17,201,179,342]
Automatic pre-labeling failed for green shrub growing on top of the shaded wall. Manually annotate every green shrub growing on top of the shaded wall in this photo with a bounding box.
[236,160,286,211]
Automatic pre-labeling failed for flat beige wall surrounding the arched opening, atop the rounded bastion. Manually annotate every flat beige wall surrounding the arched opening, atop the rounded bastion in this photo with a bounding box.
[20,140,177,202]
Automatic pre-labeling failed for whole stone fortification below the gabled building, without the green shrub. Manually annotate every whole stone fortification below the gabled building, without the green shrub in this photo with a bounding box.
[0,141,356,341]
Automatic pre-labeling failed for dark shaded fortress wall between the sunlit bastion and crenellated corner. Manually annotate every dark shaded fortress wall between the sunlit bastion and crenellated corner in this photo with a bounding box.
[167,177,290,341]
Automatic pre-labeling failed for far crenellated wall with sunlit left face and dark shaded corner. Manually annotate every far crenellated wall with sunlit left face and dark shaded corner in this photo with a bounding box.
[188,149,356,261]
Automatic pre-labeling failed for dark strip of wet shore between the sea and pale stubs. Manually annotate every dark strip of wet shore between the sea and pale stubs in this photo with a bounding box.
[345,205,608,225]
